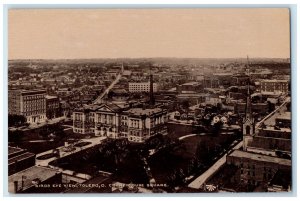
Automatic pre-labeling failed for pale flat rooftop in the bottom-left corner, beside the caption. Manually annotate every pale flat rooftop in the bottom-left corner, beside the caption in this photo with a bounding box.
[8,166,59,193]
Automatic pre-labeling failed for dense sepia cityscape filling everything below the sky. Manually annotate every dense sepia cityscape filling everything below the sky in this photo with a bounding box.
[8,56,292,193]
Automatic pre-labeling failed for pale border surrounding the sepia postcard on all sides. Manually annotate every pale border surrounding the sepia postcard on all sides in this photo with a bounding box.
[0,0,300,201]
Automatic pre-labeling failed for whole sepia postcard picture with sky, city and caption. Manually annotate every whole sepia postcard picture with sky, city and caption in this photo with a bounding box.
[7,7,296,195]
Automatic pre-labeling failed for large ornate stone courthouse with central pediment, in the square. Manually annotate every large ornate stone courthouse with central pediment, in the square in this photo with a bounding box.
[73,104,167,142]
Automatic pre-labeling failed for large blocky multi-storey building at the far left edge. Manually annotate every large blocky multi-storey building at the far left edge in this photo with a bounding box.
[8,90,46,123]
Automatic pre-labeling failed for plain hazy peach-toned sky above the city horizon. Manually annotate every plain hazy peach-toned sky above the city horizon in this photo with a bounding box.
[8,9,290,59]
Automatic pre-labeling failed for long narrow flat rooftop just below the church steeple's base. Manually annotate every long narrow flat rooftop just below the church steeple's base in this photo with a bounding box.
[229,150,292,166]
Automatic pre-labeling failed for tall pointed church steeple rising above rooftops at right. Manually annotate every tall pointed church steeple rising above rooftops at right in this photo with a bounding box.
[243,56,255,151]
